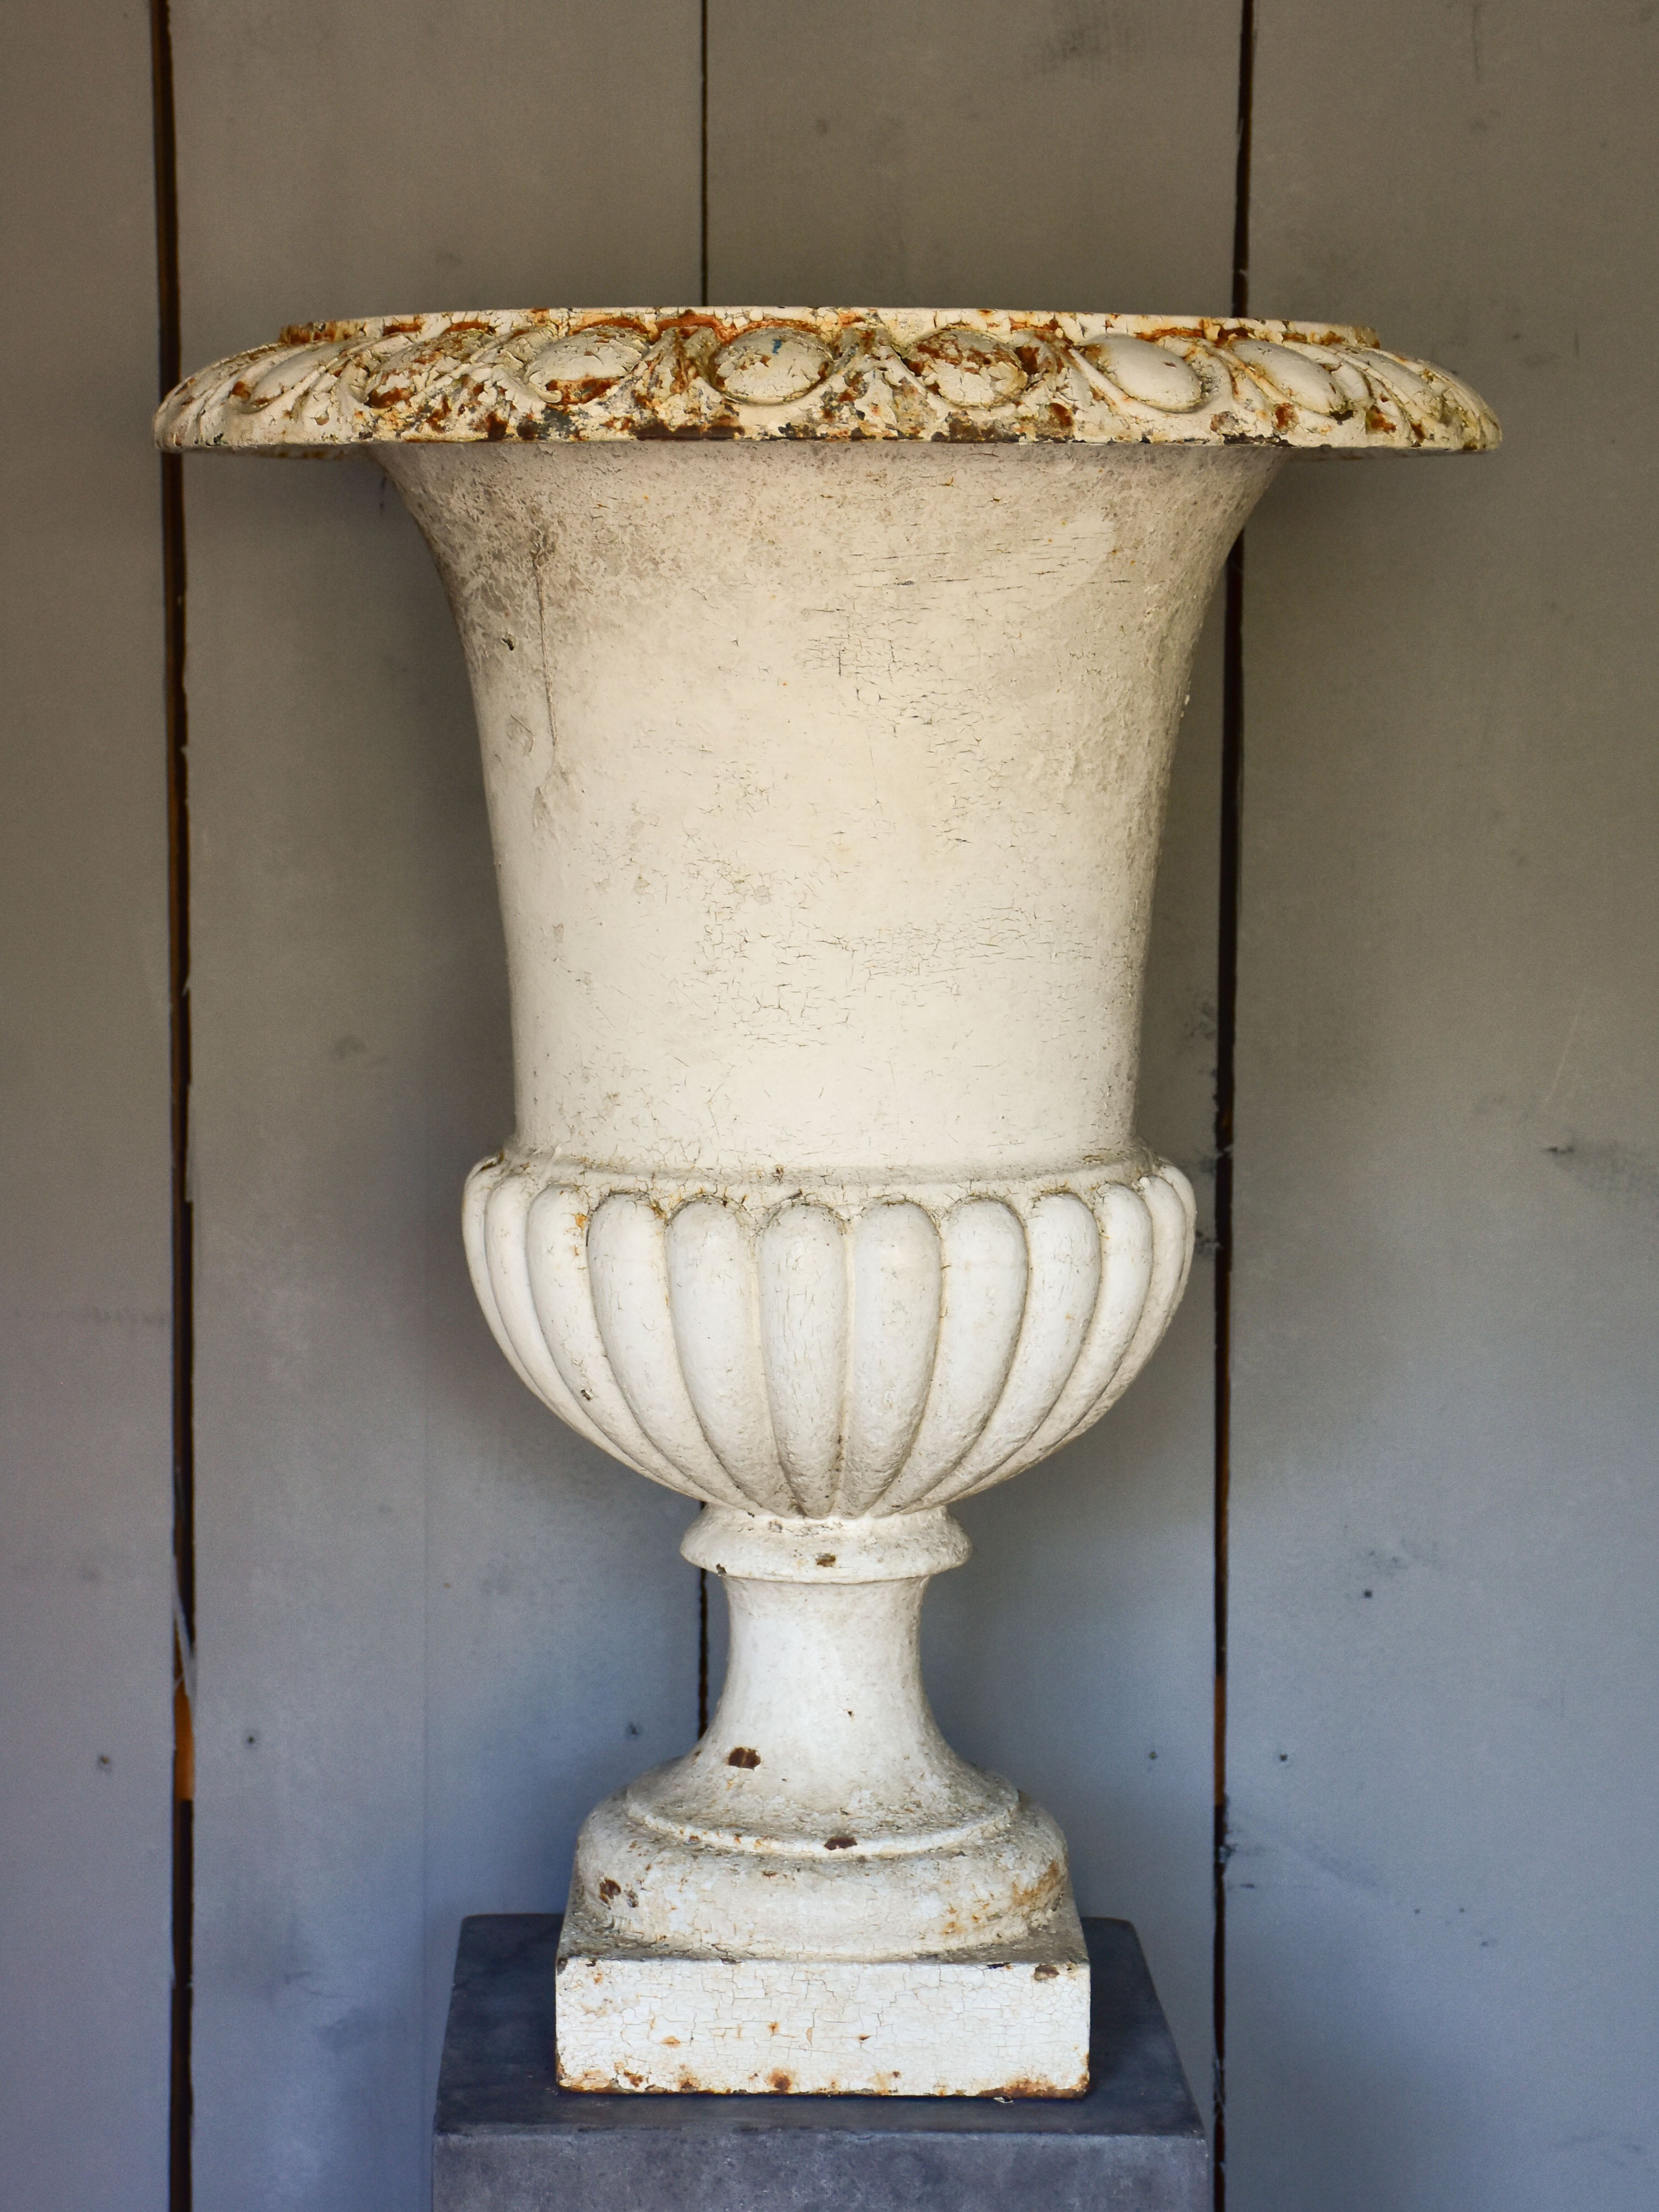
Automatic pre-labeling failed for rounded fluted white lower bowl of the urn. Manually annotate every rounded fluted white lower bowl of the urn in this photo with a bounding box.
[465,1155,1194,1520]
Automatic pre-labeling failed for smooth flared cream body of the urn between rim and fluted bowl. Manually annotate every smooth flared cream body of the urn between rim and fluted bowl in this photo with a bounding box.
[376,442,1279,1197]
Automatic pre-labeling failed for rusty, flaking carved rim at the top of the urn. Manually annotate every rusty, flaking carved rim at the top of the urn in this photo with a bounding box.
[155,307,1500,453]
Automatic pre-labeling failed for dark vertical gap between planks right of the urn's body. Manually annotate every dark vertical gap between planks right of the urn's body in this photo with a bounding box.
[1210,0,1256,2212]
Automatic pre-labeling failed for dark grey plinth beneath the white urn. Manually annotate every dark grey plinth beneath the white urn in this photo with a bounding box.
[434,1913,1210,2212]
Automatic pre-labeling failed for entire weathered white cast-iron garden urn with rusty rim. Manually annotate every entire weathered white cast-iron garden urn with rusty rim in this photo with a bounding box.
[159,307,1498,2097]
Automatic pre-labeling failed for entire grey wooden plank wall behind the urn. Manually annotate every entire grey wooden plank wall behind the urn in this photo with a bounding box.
[0,0,1659,2212]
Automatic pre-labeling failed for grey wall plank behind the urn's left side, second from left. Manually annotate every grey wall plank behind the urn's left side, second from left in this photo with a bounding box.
[173,0,699,2212]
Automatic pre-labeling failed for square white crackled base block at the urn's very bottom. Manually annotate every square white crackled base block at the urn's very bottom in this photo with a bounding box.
[560,1913,1088,2097]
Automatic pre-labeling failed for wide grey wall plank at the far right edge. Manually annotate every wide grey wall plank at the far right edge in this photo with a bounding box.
[1228,0,1659,2212]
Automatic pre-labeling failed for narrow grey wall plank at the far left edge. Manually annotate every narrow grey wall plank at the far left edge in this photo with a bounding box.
[0,0,173,2212]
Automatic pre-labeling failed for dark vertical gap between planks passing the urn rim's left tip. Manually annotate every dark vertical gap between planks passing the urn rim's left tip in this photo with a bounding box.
[150,0,197,2212]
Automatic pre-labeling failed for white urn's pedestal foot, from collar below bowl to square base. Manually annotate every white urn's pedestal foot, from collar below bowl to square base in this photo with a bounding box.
[557,1506,1088,2097]
